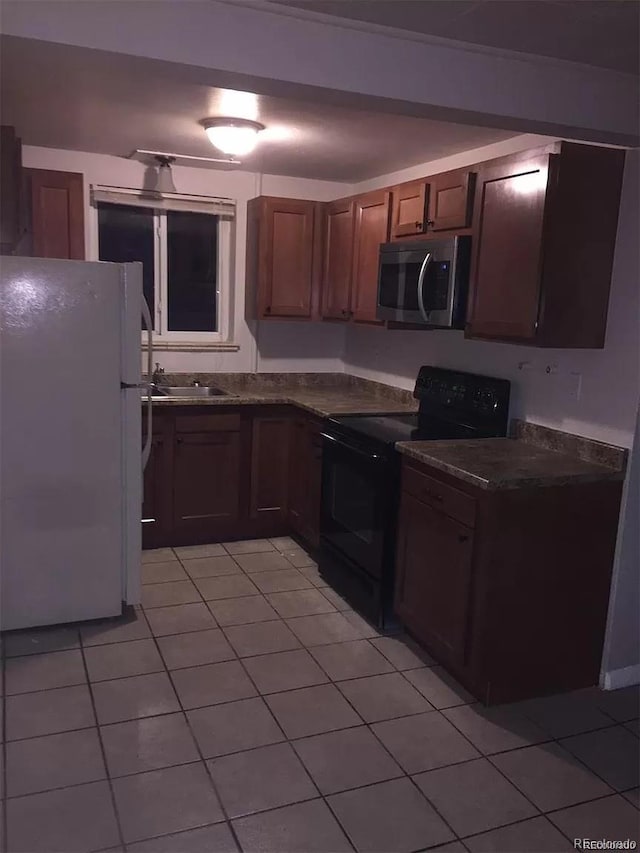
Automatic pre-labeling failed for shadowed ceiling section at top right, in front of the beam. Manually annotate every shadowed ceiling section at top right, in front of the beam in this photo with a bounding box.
[271,0,640,74]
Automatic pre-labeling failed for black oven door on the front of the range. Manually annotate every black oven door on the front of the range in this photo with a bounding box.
[320,433,393,579]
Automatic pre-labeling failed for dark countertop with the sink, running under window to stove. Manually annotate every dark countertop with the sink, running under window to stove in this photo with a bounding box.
[153,373,418,418]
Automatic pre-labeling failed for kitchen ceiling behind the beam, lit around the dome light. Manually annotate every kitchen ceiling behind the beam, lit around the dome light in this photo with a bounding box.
[0,36,514,183]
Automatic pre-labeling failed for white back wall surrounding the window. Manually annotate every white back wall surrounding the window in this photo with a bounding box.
[22,145,350,373]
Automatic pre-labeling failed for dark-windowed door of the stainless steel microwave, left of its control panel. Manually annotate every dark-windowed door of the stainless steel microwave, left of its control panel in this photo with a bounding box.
[376,248,431,323]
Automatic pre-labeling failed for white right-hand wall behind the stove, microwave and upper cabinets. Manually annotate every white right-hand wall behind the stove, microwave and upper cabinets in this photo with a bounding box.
[344,137,640,447]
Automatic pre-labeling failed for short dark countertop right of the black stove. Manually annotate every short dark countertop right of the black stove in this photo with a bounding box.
[396,438,624,491]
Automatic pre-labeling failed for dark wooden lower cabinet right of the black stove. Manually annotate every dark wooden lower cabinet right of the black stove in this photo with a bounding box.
[395,460,622,704]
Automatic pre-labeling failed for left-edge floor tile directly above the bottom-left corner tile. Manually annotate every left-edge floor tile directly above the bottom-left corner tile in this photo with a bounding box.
[6,728,107,797]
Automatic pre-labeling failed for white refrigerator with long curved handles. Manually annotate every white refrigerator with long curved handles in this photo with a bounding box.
[0,257,151,630]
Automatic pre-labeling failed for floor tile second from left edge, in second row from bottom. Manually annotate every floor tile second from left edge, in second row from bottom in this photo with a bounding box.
[100,714,199,777]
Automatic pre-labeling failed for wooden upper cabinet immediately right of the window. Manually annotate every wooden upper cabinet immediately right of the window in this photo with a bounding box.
[247,197,319,319]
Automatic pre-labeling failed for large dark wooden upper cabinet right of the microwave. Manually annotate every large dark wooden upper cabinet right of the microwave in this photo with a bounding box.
[466,142,624,348]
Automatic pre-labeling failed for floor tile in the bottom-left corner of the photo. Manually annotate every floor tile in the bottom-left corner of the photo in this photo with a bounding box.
[7,782,120,853]
